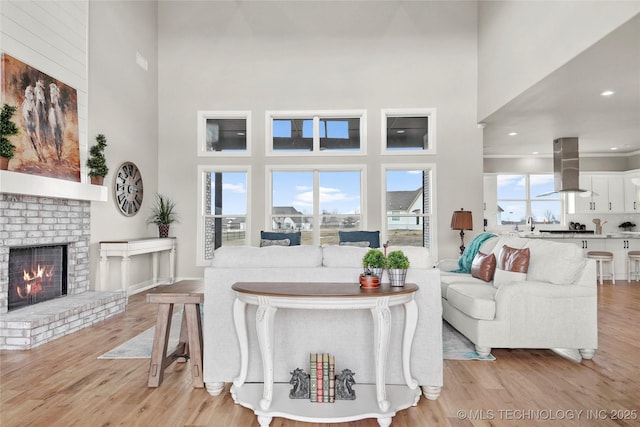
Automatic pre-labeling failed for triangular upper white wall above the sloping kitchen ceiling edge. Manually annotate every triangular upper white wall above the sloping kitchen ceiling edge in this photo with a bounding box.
[478,1,640,121]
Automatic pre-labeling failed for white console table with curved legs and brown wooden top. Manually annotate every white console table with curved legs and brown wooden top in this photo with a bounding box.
[231,282,420,427]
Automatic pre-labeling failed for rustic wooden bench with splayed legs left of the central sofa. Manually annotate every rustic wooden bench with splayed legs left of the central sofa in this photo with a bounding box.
[147,280,204,388]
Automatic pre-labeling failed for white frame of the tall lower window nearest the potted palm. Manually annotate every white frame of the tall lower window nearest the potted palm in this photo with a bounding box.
[195,165,252,267]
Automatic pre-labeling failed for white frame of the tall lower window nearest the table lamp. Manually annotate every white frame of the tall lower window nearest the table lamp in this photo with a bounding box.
[380,163,438,260]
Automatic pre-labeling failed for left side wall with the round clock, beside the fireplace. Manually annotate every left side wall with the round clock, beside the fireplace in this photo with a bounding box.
[89,1,159,289]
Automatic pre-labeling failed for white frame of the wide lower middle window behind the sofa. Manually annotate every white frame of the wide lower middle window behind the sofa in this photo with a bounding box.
[263,164,367,245]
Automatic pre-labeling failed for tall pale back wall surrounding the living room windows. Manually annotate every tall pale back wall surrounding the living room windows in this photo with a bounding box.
[158,1,482,276]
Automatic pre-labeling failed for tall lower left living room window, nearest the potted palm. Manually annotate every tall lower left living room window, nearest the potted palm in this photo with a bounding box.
[198,166,249,261]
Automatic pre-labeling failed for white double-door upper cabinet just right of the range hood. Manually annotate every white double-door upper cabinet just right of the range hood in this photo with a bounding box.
[575,175,624,213]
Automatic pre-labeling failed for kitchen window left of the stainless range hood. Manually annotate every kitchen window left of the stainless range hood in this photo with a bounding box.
[497,174,563,226]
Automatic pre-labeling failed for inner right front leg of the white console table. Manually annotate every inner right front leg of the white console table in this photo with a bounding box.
[371,298,391,411]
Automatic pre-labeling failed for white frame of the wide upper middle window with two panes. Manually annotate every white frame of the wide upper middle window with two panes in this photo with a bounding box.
[265,109,367,157]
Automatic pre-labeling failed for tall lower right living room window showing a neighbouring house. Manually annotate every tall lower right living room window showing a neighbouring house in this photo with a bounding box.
[385,166,433,248]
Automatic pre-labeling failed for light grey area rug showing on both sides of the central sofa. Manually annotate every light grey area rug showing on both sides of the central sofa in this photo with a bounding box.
[98,311,496,360]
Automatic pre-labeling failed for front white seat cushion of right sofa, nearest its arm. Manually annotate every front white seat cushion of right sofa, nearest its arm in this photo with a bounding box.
[447,283,497,320]
